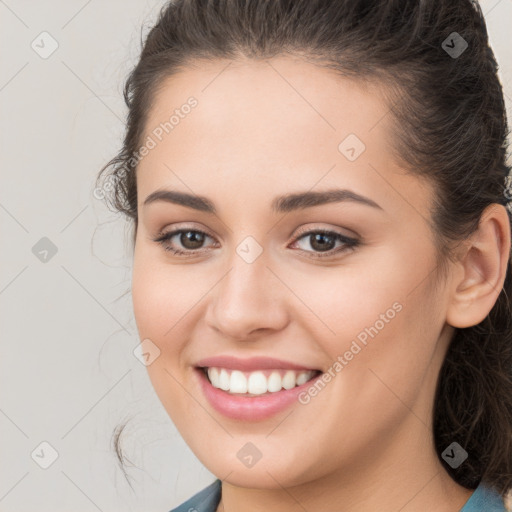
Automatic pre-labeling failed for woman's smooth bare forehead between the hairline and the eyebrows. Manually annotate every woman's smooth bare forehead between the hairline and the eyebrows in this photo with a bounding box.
[137,57,432,220]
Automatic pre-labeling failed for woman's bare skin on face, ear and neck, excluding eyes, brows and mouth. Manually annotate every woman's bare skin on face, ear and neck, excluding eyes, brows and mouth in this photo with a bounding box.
[132,56,510,512]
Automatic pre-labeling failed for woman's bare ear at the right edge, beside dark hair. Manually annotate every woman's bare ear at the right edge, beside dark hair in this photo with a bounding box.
[446,203,511,328]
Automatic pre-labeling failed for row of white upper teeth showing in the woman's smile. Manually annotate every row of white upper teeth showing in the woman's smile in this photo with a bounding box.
[207,368,316,395]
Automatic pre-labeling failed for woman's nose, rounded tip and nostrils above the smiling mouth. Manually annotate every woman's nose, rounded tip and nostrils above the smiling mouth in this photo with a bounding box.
[205,253,289,341]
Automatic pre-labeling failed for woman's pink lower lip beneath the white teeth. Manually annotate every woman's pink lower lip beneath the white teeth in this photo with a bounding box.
[195,368,322,421]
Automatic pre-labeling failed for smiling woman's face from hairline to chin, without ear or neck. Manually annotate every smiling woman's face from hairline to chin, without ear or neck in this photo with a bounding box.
[133,57,453,488]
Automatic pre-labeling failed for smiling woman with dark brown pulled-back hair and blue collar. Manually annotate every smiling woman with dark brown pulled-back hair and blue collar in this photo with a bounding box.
[97,0,512,512]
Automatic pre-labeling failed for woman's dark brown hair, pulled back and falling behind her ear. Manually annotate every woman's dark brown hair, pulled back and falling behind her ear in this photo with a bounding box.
[98,0,512,502]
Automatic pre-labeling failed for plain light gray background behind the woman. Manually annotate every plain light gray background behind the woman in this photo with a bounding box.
[0,0,512,512]
